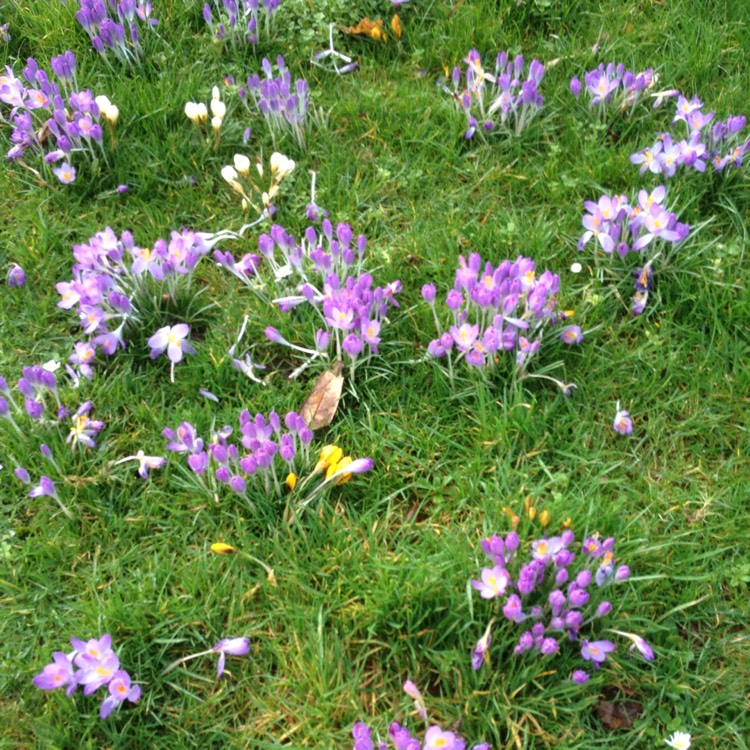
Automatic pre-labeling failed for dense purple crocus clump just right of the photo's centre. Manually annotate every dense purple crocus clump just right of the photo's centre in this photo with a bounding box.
[422,253,583,395]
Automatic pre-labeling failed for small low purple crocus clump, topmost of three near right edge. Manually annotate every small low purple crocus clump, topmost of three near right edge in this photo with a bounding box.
[570,63,656,111]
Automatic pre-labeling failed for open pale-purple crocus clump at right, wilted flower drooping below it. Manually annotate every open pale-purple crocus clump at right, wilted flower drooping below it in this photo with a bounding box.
[578,185,690,315]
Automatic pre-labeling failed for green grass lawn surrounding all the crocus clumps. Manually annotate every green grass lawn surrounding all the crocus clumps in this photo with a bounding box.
[0,0,750,750]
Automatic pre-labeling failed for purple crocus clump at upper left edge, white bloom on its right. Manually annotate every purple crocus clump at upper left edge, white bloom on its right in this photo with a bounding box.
[0,51,119,185]
